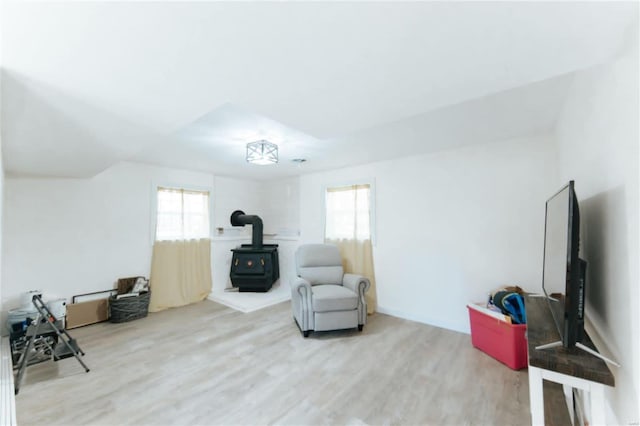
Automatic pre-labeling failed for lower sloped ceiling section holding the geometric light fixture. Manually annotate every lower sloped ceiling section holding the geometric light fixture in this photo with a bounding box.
[133,74,572,179]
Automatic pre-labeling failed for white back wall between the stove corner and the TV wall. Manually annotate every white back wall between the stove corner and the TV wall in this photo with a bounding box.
[300,136,556,332]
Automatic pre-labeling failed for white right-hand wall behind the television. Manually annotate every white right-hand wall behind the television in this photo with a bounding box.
[556,28,640,424]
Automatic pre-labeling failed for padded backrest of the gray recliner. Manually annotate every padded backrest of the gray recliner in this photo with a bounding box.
[296,244,344,285]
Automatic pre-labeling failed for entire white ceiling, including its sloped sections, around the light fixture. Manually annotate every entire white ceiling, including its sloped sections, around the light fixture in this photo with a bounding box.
[1,1,638,179]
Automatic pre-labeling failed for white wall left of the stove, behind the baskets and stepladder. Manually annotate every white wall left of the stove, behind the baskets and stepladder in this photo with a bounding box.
[3,163,213,310]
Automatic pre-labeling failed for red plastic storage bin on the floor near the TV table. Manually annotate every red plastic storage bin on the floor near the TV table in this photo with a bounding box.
[467,306,528,370]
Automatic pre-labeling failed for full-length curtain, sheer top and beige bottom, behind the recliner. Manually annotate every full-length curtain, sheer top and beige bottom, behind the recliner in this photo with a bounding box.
[325,184,377,314]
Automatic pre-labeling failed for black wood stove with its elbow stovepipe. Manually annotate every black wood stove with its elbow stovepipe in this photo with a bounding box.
[229,210,280,292]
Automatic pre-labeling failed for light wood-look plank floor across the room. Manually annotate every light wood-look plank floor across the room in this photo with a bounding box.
[16,301,530,425]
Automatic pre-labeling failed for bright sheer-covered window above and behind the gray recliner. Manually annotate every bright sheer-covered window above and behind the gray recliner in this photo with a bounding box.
[325,184,372,240]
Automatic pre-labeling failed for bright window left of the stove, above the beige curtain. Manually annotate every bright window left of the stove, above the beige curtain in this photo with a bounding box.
[156,187,210,240]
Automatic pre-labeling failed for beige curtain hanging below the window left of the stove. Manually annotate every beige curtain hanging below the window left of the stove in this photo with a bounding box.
[149,238,211,312]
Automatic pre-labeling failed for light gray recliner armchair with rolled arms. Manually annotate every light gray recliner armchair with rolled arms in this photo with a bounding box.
[291,244,371,337]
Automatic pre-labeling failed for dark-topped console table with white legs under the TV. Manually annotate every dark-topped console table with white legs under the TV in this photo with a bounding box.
[525,295,615,425]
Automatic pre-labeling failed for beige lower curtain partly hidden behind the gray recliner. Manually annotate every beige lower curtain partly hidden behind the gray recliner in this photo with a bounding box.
[326,239,378,314]
